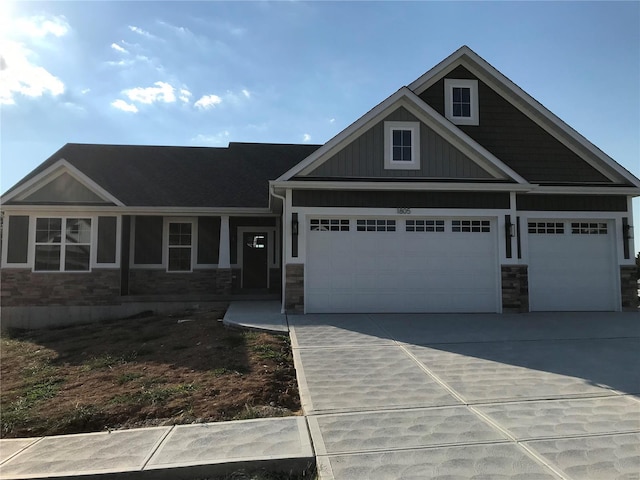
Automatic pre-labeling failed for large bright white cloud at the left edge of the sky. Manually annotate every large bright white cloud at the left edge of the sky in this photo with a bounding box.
[0,41,65,105]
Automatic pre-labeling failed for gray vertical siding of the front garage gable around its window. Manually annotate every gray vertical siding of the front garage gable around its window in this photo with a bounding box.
[307,107,493,179]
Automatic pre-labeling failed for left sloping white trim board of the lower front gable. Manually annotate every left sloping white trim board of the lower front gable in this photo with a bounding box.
[275,87,406,182]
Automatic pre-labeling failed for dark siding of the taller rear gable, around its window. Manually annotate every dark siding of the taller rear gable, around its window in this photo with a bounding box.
[420,66,611,183]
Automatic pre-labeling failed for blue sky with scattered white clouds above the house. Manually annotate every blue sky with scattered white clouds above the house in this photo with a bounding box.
[0,1,640,248]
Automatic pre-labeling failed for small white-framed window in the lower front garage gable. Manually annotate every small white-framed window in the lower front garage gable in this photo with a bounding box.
[384,122,420,170]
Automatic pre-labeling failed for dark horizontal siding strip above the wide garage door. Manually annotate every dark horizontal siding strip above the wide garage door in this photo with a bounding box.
[293,190,509,209]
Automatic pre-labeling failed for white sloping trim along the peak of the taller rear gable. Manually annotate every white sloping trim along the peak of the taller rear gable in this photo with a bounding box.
[409,46,640,187]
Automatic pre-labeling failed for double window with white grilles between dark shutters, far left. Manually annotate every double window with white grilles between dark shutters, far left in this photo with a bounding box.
[34,217,91,272]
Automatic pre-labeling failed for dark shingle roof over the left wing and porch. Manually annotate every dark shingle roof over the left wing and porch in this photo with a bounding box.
[6,143,319,208]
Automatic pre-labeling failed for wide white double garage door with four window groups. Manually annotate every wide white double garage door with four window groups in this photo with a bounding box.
[305,218,499,313]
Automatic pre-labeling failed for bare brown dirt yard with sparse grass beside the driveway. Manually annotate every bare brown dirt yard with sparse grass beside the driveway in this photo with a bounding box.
[0,311,300,438]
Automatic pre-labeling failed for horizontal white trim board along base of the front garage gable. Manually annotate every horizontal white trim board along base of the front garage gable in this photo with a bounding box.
[273,180,536,192]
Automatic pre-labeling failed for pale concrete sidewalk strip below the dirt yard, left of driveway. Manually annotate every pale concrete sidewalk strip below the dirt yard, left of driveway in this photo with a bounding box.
[0,417,315,480]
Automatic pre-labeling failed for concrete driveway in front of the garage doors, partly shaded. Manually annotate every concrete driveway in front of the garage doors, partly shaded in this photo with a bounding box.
[289,313,640,480]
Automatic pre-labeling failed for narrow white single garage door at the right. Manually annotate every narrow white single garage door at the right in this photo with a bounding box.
[528,220,617,311]
